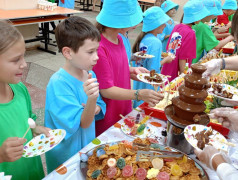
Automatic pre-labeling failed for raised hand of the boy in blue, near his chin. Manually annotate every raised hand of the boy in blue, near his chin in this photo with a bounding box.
[83,73,99,99]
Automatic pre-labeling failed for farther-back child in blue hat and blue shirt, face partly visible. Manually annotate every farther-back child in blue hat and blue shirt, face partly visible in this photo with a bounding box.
[157,0,179,52]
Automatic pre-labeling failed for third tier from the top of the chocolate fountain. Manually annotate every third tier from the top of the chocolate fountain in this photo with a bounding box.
[178,85,208,104]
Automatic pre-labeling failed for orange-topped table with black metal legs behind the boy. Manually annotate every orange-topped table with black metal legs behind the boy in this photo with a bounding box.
[0,7,82,54]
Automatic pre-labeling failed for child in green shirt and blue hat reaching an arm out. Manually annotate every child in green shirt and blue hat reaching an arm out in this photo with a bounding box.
[192,0,233,63]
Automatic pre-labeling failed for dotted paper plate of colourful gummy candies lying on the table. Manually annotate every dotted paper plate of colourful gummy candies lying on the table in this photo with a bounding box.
[121,113,166,139]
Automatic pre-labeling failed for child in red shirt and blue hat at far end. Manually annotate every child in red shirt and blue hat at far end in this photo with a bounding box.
[217,0,237,32]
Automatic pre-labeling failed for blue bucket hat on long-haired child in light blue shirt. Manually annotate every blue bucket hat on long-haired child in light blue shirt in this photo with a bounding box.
[142,6,170,32]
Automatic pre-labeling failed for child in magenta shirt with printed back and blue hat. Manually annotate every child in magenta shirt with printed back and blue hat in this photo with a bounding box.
[161,0,209,81]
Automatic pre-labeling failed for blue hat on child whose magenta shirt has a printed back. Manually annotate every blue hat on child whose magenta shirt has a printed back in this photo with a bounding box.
[183,0,209,24]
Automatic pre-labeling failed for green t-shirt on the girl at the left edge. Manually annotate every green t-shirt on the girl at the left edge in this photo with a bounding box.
[0,83,44,180]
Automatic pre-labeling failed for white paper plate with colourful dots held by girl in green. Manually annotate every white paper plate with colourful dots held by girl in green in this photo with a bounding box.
[22,129,66,158]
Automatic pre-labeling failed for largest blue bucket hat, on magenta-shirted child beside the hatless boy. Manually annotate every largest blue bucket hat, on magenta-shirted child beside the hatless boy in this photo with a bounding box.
[96,0,143,28]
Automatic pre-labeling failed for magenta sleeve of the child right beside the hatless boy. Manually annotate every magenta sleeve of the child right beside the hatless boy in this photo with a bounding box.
[93,46,114,89]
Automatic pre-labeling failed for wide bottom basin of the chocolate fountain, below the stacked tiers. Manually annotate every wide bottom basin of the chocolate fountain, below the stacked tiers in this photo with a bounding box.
[164,104,210,128]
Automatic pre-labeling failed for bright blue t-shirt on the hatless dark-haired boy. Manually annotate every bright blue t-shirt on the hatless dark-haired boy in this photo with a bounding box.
[45,68,106,173]
